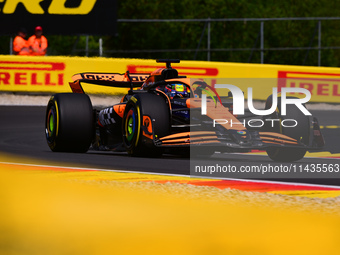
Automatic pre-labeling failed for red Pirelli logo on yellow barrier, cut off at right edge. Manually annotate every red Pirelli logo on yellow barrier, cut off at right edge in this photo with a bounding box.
[278,71,340,97]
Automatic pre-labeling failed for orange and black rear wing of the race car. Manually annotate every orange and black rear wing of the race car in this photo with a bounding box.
[69,71,150,93]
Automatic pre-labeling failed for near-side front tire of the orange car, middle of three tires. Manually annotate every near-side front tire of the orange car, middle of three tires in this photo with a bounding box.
[122,92,171,157]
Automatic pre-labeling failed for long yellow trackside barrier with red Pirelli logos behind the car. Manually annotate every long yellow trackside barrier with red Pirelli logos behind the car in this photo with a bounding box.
[0,55,340,103]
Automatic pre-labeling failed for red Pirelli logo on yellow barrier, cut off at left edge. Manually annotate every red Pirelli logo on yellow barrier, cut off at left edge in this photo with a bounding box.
[0,61,65,88]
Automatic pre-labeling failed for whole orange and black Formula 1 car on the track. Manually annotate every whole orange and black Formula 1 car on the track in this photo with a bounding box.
[45,59,324,162]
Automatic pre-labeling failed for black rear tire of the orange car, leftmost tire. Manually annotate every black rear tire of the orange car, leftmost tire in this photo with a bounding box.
[45,93,95,153]
